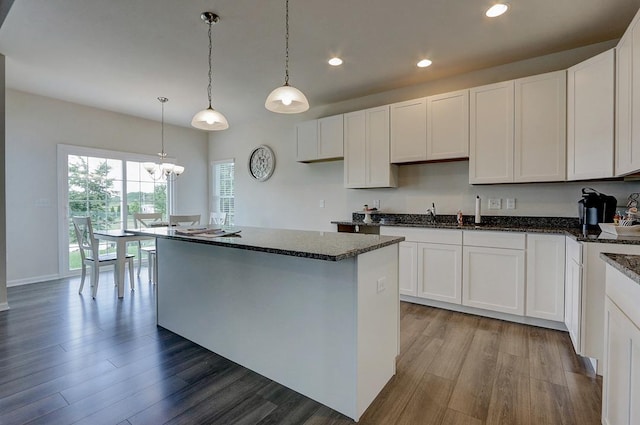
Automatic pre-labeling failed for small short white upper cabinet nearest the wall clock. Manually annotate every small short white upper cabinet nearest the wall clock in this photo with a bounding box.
[296,114,344,162]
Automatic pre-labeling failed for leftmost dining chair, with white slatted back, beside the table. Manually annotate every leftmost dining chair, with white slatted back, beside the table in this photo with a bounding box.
[72,217,134,298]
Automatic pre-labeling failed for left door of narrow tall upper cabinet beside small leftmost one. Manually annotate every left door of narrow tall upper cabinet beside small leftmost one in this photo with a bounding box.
[344,111,367,187]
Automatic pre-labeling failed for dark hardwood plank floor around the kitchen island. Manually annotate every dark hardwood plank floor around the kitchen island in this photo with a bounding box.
[0,270,601,425]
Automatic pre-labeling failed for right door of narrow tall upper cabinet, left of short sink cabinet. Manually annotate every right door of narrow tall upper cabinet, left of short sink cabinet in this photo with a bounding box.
[365,105,397,187]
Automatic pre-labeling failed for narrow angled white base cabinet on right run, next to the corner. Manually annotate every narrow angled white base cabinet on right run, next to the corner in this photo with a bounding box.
[564,236,582,354]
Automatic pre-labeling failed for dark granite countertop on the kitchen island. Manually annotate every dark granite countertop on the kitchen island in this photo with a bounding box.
[128,227,404,261]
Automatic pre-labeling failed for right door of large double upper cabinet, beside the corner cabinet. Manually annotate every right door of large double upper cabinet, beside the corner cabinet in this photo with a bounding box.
[514,70,568,182]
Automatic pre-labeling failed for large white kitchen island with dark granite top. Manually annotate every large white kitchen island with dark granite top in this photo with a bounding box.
[134,227,404,421]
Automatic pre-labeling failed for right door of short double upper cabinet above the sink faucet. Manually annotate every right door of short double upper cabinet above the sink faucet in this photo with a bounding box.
[427,90,469,161]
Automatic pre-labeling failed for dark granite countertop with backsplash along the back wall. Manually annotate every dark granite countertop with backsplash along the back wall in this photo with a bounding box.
[331,213,640,245]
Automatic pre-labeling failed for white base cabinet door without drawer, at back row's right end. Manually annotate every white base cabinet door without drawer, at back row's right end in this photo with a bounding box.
[525,233,566,322]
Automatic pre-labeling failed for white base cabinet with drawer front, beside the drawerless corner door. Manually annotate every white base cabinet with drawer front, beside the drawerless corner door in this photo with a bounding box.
[462,231,525,316]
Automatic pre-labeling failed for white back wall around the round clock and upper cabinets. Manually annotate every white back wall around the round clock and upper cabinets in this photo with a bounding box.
[209,41,640,230]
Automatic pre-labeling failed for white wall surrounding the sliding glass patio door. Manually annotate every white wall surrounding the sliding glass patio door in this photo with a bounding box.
[6,90,208,286]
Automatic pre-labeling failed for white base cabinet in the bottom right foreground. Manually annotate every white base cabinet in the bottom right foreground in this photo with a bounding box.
[602,265,640,425]
